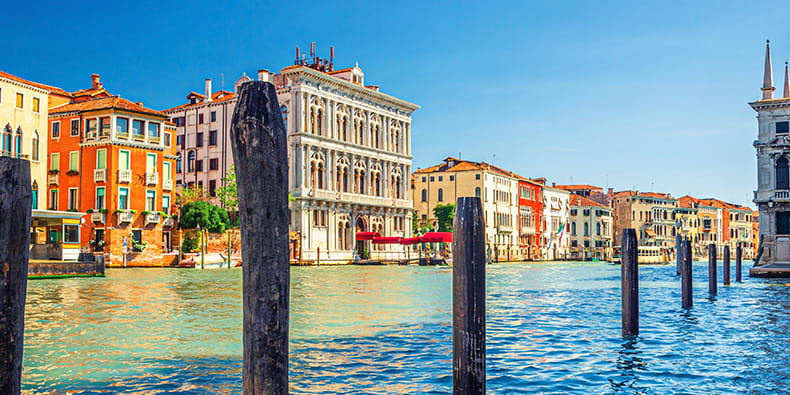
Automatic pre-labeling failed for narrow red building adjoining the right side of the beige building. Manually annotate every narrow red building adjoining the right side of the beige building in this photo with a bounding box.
[518,179,543,260]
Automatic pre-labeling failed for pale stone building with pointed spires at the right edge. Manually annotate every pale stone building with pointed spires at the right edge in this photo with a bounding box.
[749,42,790,277]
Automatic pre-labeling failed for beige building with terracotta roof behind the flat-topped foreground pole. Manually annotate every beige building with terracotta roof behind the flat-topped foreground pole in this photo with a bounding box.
[413,157,523,261]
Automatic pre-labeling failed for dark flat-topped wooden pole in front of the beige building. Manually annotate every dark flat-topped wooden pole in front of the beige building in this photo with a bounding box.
[453,197,486,394]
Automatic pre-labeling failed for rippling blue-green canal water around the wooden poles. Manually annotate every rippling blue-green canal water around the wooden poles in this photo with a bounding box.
[23,262,790,394]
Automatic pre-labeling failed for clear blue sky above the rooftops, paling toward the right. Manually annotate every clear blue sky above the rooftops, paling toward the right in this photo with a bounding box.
[0,0,790,207]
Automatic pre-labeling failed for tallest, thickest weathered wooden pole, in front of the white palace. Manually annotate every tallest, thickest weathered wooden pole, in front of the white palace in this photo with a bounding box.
[231,81,290,395]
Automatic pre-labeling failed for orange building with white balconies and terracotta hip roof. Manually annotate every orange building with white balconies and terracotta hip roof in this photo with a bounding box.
[47,74,176,266]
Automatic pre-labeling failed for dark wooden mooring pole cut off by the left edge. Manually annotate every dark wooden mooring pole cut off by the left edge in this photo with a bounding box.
[0,157,33,394]
